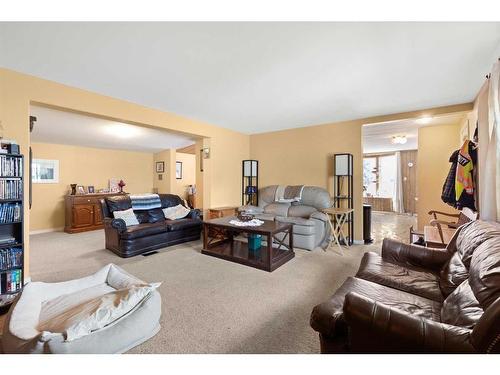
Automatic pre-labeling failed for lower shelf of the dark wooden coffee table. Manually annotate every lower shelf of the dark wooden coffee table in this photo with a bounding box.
[201,240,295,272]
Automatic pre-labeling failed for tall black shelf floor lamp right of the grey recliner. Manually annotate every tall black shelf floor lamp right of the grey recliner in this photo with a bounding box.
[333,153,354,245]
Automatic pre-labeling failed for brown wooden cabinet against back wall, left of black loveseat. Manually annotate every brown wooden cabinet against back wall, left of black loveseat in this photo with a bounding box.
[64,193,126,233]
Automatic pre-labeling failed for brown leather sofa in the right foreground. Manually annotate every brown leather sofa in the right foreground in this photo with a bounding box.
[311,220,500,353]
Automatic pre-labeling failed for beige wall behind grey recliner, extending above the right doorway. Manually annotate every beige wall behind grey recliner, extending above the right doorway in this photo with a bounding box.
[250,103,472,241]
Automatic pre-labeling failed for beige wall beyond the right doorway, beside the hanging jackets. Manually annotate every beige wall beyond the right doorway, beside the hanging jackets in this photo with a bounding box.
[417,123,461,230]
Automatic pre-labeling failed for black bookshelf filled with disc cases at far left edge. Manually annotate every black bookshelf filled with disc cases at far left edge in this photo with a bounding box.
[0,154,24,314]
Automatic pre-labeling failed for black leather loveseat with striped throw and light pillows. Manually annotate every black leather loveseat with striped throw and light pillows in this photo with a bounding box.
[101,194,202,258]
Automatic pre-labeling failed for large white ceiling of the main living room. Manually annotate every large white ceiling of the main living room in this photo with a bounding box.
[0,22,500,133]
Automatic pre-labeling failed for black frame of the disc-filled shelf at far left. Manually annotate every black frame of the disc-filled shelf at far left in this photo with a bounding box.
[0,154,24,314]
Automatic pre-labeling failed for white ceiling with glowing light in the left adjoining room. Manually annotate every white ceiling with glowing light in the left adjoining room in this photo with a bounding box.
[30,106,195,152]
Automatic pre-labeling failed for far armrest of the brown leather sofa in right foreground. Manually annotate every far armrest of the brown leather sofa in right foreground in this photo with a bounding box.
[382,238,451,270]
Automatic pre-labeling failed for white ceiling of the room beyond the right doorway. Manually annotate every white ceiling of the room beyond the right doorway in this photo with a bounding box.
[363,113,465,154]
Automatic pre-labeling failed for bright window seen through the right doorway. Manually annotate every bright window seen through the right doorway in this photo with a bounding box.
[363,154,396,198]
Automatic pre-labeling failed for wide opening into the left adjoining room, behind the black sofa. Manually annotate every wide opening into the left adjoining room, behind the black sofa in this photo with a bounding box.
[26,105,203,281]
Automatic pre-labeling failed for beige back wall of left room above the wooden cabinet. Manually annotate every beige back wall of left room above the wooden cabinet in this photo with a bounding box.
[30,143,153,232]
